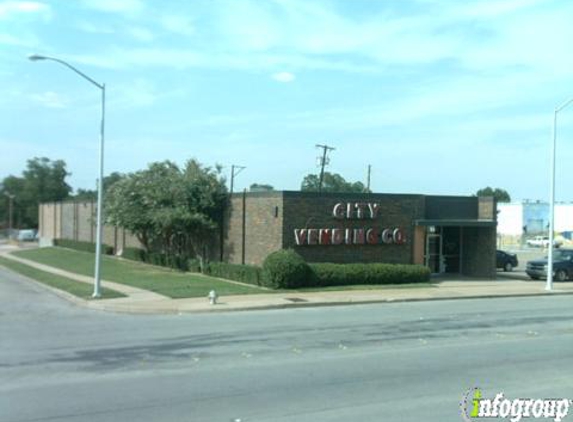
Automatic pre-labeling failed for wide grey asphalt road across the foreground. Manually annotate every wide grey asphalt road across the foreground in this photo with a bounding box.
[0,269,573,422]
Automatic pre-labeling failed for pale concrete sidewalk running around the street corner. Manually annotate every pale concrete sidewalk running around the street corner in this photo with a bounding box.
[1,251,573,314]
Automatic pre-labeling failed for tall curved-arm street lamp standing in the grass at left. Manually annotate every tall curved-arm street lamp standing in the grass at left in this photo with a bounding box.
[28,54,105,297]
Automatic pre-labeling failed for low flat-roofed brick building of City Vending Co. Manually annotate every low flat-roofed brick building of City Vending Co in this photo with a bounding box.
[39,191,496,278]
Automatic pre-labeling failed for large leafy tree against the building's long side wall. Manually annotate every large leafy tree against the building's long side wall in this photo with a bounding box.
[106,160,227,265]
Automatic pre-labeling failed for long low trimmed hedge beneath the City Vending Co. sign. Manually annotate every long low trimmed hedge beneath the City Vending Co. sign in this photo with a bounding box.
[306,263,430,287]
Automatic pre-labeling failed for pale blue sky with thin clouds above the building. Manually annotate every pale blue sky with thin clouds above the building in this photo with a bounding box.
[0,0,573,201]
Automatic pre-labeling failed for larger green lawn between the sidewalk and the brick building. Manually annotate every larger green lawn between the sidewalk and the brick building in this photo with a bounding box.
[13,248,268,298]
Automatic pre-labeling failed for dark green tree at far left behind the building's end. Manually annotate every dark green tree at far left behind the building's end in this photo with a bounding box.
[0,157,72,228]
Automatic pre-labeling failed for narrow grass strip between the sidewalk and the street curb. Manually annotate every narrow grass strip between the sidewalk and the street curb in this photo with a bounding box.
[0,257,125,299]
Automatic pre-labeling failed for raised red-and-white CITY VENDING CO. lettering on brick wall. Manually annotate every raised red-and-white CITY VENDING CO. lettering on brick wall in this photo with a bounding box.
[294,202,406,246]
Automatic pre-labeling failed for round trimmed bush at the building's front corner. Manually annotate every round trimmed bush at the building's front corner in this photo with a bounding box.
[262,249,309,289]
